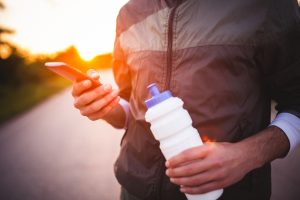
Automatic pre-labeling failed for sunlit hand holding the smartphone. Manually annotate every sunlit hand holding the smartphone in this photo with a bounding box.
[72,70,120,121]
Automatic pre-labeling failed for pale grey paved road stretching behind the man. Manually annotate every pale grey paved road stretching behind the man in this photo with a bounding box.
[0,71,300,200]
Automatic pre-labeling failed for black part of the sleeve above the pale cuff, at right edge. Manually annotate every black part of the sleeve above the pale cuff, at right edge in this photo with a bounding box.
[263,3,300,118]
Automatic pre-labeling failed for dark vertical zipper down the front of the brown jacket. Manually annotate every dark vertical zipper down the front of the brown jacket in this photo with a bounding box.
[165,1,181,90]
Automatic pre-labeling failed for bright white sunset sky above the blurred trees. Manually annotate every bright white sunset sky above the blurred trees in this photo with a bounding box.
[0,0,127,60]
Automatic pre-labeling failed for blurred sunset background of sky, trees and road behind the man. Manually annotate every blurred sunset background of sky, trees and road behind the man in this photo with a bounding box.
[0,0,300,200]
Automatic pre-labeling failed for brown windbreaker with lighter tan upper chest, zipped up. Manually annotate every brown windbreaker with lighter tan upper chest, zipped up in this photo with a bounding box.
[113,0,300,200]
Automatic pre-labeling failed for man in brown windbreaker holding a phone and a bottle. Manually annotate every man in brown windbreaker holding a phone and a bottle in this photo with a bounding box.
[73,0,300,200]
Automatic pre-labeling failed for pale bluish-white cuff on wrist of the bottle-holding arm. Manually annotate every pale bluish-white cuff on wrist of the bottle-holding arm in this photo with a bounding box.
[271,112,300,154]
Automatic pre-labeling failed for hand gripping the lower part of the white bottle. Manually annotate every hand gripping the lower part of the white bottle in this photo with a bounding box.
[166,143,253,194]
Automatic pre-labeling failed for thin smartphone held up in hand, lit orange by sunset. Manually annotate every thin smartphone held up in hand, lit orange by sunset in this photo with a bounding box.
[45,62,101,87]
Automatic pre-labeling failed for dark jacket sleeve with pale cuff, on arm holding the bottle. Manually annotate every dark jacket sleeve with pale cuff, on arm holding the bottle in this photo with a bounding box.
[263,1,300,153]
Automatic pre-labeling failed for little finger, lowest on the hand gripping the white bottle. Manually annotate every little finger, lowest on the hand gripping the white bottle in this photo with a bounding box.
[180,181,224,194]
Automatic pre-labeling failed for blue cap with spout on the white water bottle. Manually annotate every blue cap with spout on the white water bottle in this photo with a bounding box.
[145,83,172,108]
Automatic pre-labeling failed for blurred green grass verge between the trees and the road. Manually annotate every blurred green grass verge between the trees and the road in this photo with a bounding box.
[0,77,70,125]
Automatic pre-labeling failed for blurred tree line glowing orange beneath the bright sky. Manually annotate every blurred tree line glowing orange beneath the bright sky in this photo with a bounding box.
[0,0,112,89]
